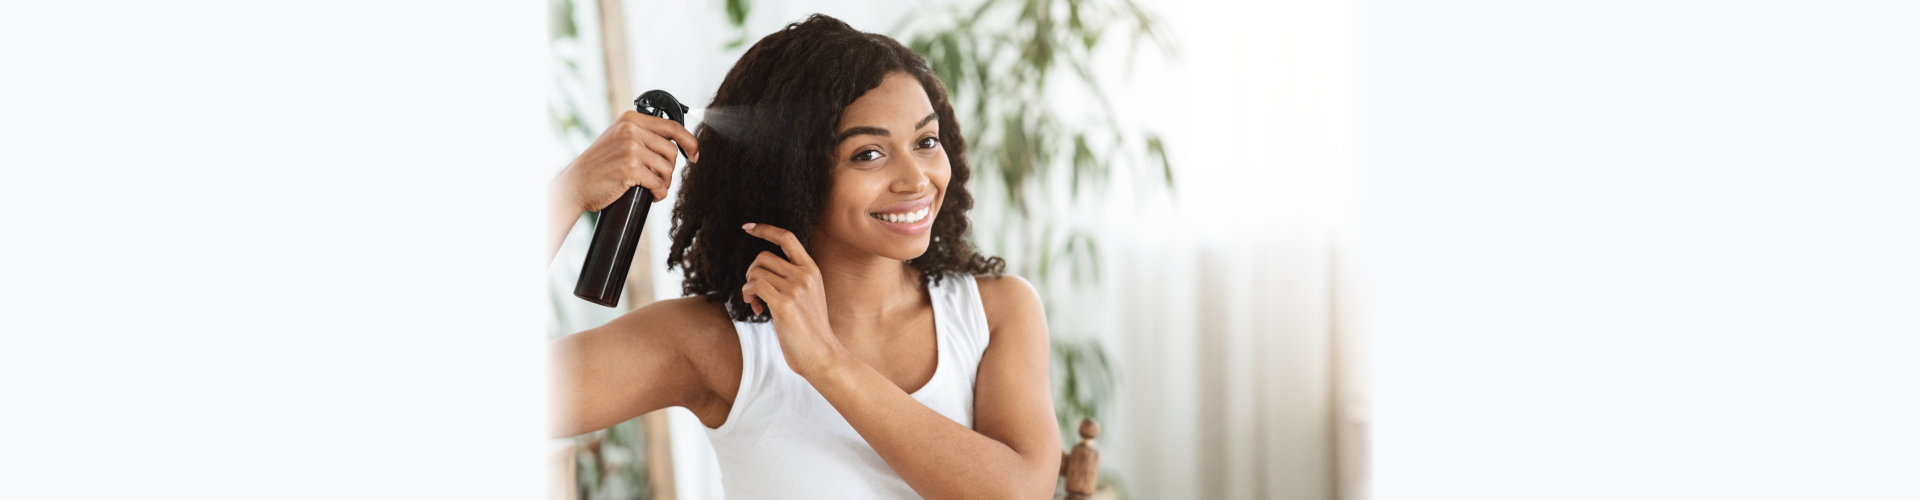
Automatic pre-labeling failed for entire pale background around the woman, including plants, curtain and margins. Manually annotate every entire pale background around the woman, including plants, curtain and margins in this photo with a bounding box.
[0,0,1920,500]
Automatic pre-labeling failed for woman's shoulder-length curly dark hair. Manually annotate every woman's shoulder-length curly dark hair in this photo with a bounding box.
[666,13,1006,323]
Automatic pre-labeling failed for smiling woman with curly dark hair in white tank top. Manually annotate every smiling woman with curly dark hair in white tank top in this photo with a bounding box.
[551,15,1060,498]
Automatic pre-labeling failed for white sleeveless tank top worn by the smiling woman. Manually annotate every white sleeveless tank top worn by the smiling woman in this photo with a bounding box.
[703,273,987,500]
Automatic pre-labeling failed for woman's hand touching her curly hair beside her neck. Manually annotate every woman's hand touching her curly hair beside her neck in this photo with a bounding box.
[739,223,852,379]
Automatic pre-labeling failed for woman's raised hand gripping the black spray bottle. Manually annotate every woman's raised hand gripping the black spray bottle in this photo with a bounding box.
[553,110,701,215]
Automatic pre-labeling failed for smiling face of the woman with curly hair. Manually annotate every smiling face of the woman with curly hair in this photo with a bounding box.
[818,73,952,260]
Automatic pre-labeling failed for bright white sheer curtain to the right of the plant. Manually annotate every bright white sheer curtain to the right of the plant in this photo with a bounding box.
[1100,0,1365,498]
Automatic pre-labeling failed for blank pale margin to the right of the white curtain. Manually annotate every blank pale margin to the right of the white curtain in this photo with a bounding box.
[1352,0,1920,498]
